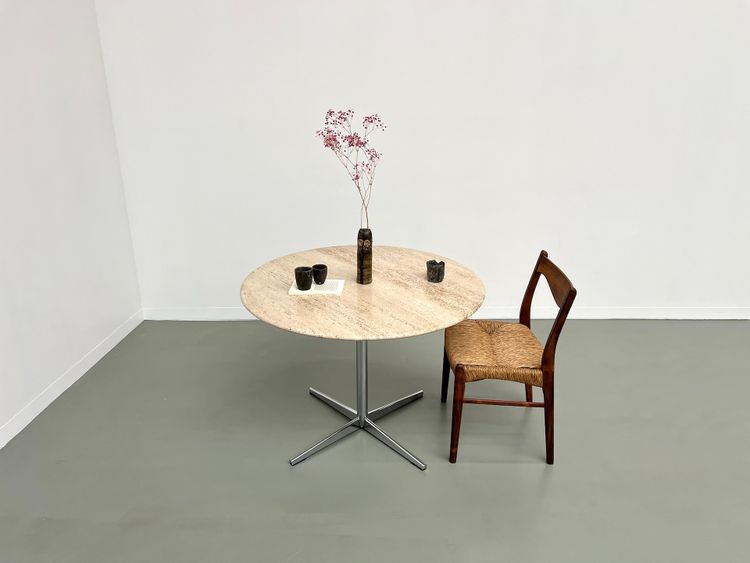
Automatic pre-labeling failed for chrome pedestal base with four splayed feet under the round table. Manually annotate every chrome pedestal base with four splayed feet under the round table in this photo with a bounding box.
[289,340,427,471]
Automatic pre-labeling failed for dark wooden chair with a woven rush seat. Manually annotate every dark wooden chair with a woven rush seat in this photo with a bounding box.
[440,250,576,464]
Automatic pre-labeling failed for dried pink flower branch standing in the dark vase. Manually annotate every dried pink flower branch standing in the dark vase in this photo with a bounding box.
[316,109,386,228]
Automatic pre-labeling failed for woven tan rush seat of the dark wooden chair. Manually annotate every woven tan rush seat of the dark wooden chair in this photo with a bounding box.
[445,320,543,387]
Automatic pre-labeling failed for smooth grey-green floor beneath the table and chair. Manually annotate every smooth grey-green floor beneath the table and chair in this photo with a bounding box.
[0,321,750,563]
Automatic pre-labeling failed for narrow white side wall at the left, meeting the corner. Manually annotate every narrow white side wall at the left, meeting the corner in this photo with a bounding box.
[0,0,140,447]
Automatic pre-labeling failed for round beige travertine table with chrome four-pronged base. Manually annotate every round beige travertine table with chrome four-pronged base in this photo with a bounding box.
[241,246,484,469]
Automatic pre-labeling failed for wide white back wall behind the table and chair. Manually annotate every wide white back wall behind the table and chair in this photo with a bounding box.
[97,0,750,318]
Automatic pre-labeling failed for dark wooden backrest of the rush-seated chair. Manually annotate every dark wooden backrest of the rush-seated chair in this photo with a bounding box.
[519,250,577,378]
